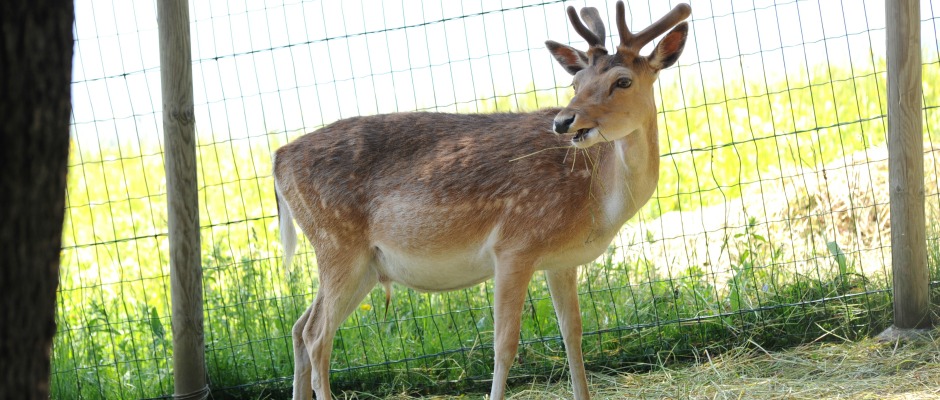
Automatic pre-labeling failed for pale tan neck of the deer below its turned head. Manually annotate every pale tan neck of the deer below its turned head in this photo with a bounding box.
[591,120,659,231]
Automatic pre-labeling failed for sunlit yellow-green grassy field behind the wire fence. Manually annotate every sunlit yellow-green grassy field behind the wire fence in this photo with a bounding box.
[52,63,940,399]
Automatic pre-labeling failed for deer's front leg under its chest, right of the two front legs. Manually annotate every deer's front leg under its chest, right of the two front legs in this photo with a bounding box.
[545,267,591,400]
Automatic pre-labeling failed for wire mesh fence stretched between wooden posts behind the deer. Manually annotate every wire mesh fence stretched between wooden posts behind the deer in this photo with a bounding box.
[52,0,940,399]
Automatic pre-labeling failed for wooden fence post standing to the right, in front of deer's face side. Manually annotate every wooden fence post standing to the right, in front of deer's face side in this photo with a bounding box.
[885,0,931,330]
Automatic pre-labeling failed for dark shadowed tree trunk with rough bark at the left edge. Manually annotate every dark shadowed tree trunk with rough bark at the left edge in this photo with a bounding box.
[0,0,75,399]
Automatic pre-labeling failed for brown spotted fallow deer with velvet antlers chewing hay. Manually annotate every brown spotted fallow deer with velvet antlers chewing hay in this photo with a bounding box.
[274,2,691,400]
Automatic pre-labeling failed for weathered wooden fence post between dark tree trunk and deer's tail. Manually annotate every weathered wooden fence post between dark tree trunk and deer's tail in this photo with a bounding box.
[157,0,209,399]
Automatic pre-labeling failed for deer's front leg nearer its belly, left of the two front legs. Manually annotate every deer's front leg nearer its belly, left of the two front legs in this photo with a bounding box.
[490,259,534,400]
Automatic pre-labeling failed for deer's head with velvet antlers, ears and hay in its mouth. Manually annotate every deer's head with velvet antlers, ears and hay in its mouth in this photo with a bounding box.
[545,1,692,148]
